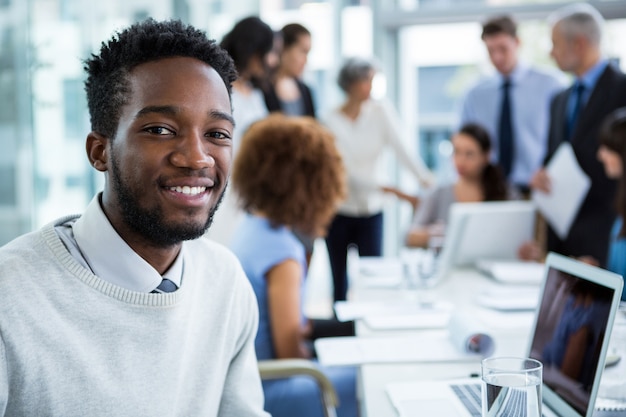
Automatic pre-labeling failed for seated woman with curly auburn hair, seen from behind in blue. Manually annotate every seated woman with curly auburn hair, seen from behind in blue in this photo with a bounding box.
[231,114,358,417]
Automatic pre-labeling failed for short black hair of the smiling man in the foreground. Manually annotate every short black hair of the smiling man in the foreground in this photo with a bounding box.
[84,19,237,138]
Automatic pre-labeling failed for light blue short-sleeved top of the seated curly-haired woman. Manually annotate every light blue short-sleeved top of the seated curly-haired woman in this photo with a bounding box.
[231,214,306,360]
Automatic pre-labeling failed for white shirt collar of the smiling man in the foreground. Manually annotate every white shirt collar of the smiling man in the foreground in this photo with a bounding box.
[72,194,184,292]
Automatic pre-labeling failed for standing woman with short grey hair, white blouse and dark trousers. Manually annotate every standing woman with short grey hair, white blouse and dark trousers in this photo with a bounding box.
[323,58,432,301]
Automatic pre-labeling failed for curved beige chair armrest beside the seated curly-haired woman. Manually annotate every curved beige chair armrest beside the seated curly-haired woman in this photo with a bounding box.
[258,359,339,417]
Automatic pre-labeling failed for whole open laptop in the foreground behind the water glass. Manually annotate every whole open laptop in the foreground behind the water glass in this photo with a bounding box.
[387,253,623,417]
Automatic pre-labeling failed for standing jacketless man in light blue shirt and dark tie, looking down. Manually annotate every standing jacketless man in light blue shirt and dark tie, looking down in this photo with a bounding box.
[460,16,563,194]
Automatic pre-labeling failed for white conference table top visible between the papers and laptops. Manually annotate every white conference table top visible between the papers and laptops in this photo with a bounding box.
[349,258,626,417]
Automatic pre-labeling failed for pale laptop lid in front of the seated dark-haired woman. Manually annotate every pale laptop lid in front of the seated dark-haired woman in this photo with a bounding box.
[438,201,536,278]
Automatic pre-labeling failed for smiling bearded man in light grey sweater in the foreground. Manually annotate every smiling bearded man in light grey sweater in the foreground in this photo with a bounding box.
[0,20,266,417]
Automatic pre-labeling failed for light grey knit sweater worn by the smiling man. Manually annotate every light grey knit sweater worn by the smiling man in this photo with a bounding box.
[0,217,267,417]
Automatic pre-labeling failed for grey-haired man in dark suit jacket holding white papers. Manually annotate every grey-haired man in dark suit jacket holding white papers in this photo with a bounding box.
[531,4,626,265]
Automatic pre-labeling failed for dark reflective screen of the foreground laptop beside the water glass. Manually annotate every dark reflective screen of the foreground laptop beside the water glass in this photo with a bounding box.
[530,260,615,416]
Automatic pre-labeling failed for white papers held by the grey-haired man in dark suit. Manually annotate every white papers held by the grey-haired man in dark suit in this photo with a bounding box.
[532,142,591,239]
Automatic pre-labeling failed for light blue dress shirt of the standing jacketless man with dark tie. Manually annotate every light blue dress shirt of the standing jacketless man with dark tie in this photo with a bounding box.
[459,64,564,185]
